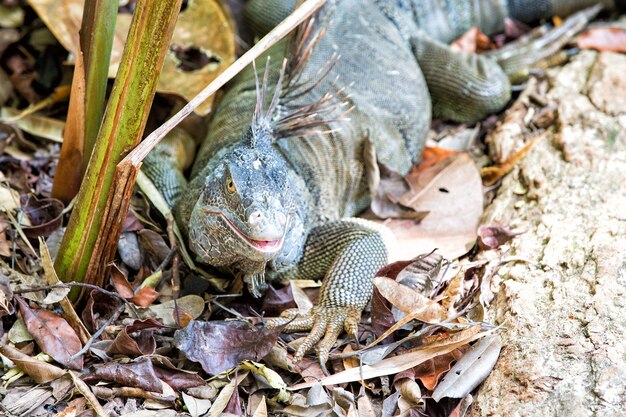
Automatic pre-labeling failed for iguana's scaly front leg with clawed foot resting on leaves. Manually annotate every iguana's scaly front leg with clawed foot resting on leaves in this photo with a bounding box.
[268,219,390,364]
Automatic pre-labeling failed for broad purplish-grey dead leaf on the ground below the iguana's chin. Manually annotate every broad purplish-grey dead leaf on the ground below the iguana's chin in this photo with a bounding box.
[174,321,280,375]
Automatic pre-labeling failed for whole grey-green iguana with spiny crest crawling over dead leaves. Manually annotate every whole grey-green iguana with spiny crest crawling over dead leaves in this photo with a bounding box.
[143,0,624,363]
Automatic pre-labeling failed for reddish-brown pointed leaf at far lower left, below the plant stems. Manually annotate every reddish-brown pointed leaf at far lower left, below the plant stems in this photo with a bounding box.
[15,296,83,370]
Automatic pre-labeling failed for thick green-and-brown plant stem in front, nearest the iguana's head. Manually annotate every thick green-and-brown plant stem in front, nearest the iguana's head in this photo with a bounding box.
[54,0,182,299]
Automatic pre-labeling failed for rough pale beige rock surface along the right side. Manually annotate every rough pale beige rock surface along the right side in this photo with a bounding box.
[472,51,626,417]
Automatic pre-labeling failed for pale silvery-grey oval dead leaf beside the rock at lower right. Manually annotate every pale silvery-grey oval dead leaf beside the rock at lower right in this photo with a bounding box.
[432,335,502,402]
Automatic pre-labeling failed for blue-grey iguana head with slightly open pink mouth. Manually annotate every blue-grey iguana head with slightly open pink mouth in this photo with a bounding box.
[182,120,301,295]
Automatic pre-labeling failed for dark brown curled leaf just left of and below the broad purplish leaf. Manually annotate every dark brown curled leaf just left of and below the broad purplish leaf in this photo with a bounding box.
[90,358,162,392]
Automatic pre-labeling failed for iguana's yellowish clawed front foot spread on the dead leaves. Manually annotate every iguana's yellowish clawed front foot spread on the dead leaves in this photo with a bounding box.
[268,306,361,364]
